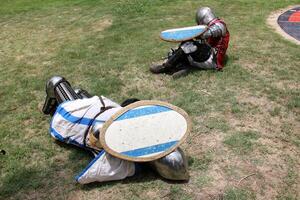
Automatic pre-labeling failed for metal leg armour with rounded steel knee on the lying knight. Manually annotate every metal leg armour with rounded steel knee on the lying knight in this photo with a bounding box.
[43,76,80,115]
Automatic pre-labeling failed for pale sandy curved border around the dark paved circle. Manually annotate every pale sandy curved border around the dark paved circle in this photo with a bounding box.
[267,5,300,45]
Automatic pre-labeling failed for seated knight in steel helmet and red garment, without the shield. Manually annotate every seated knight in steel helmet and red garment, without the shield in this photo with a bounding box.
[150,7,230,78]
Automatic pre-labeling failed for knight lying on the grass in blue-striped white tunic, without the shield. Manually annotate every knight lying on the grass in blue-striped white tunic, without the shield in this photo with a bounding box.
[43,76,189,184]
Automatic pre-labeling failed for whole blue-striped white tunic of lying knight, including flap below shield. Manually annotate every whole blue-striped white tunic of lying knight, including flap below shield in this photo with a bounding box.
[50,96,135,184]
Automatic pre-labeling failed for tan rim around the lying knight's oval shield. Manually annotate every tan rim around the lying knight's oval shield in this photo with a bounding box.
[100,100,191,162]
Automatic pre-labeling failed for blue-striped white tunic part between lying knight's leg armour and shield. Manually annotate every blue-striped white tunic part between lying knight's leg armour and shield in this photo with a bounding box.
[50,96,121,147]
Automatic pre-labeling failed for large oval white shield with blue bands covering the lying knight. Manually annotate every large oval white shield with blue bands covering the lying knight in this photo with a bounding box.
[100,101,191,162]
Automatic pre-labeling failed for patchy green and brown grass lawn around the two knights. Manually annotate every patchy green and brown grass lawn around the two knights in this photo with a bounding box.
[0,0,300,200]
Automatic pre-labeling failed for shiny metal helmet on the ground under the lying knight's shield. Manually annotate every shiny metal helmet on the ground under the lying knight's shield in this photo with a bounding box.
[151,148,190,181]
